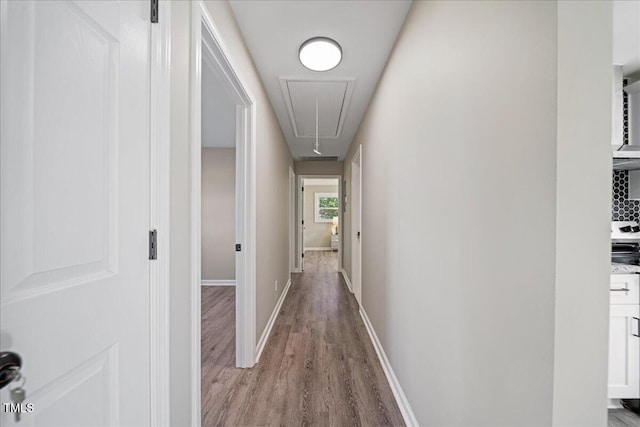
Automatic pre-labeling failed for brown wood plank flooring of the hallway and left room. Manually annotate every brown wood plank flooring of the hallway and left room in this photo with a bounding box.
[202,264,404,426]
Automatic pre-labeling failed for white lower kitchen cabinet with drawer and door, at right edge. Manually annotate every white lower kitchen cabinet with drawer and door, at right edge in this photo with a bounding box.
[608,274,640,399]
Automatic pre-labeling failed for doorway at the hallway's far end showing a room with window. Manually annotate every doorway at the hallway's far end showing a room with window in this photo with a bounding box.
[298,175,343,273]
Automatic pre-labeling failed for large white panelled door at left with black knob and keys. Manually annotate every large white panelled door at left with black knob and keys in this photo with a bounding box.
[0,0,150,427]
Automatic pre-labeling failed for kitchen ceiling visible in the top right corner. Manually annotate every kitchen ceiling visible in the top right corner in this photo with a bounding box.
[613,0,640,76]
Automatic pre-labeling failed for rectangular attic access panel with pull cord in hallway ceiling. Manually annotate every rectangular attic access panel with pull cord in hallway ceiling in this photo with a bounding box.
[280,78,353,139]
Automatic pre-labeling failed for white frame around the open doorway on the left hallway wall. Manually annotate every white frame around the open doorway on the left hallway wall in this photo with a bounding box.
[190,1,256,425]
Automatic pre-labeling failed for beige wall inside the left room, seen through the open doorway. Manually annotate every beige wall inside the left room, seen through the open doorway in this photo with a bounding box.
[200,148,236,281]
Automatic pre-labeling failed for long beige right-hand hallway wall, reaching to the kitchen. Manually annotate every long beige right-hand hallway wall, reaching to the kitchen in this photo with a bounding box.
[344,1,611,426]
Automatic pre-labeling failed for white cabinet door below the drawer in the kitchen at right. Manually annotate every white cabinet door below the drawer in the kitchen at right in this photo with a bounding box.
[608,304,640,399]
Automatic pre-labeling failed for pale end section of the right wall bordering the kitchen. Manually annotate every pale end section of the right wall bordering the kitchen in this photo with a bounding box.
[553,1,612,427]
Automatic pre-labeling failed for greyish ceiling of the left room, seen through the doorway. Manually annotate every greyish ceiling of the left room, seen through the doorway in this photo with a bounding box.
[201,53,236,148]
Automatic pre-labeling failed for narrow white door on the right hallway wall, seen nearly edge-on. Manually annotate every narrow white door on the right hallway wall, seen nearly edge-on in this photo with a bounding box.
[351,147,362,305]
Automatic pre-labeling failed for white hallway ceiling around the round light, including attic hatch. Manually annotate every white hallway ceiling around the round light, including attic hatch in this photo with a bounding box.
[231,0,411,159]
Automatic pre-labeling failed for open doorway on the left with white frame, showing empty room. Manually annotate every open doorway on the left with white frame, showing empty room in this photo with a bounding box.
[190,2,256,420]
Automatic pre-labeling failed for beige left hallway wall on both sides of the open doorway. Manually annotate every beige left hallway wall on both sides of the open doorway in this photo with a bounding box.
[170,1,293,426]
